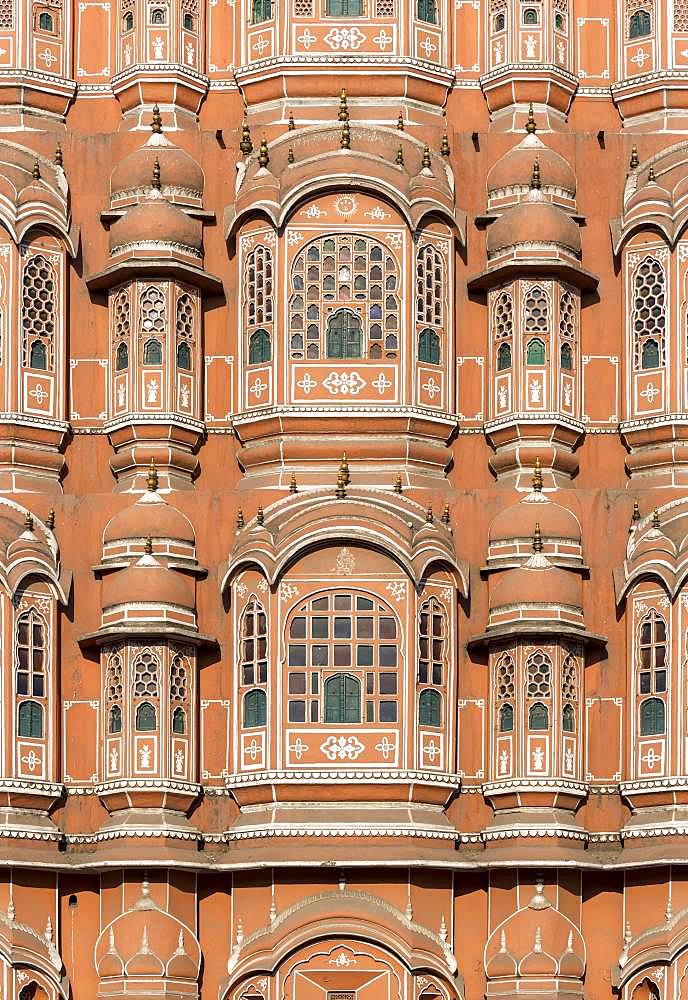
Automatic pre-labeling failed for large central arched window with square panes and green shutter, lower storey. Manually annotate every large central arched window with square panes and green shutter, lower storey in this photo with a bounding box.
[287,591,400,724]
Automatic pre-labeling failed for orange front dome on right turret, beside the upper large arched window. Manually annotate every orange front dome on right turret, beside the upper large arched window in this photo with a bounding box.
[487,189,581,257]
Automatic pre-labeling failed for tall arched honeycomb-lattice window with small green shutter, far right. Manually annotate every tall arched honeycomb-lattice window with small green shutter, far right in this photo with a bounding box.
[631,257,666,371]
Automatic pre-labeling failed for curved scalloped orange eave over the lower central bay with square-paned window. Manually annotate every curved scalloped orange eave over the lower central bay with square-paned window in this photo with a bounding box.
[220,488,469,596]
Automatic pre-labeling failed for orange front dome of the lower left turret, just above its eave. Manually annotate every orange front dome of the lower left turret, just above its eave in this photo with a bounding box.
[102,556,196,611]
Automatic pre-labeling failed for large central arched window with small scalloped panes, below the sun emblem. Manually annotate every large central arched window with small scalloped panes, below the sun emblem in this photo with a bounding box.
[289,233,401,360]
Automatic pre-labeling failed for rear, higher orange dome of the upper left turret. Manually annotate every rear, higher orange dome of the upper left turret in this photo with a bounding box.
[110,132,204,200]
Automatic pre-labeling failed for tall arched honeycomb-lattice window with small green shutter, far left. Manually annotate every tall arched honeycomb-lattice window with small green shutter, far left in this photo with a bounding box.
[22,254,57,371]
